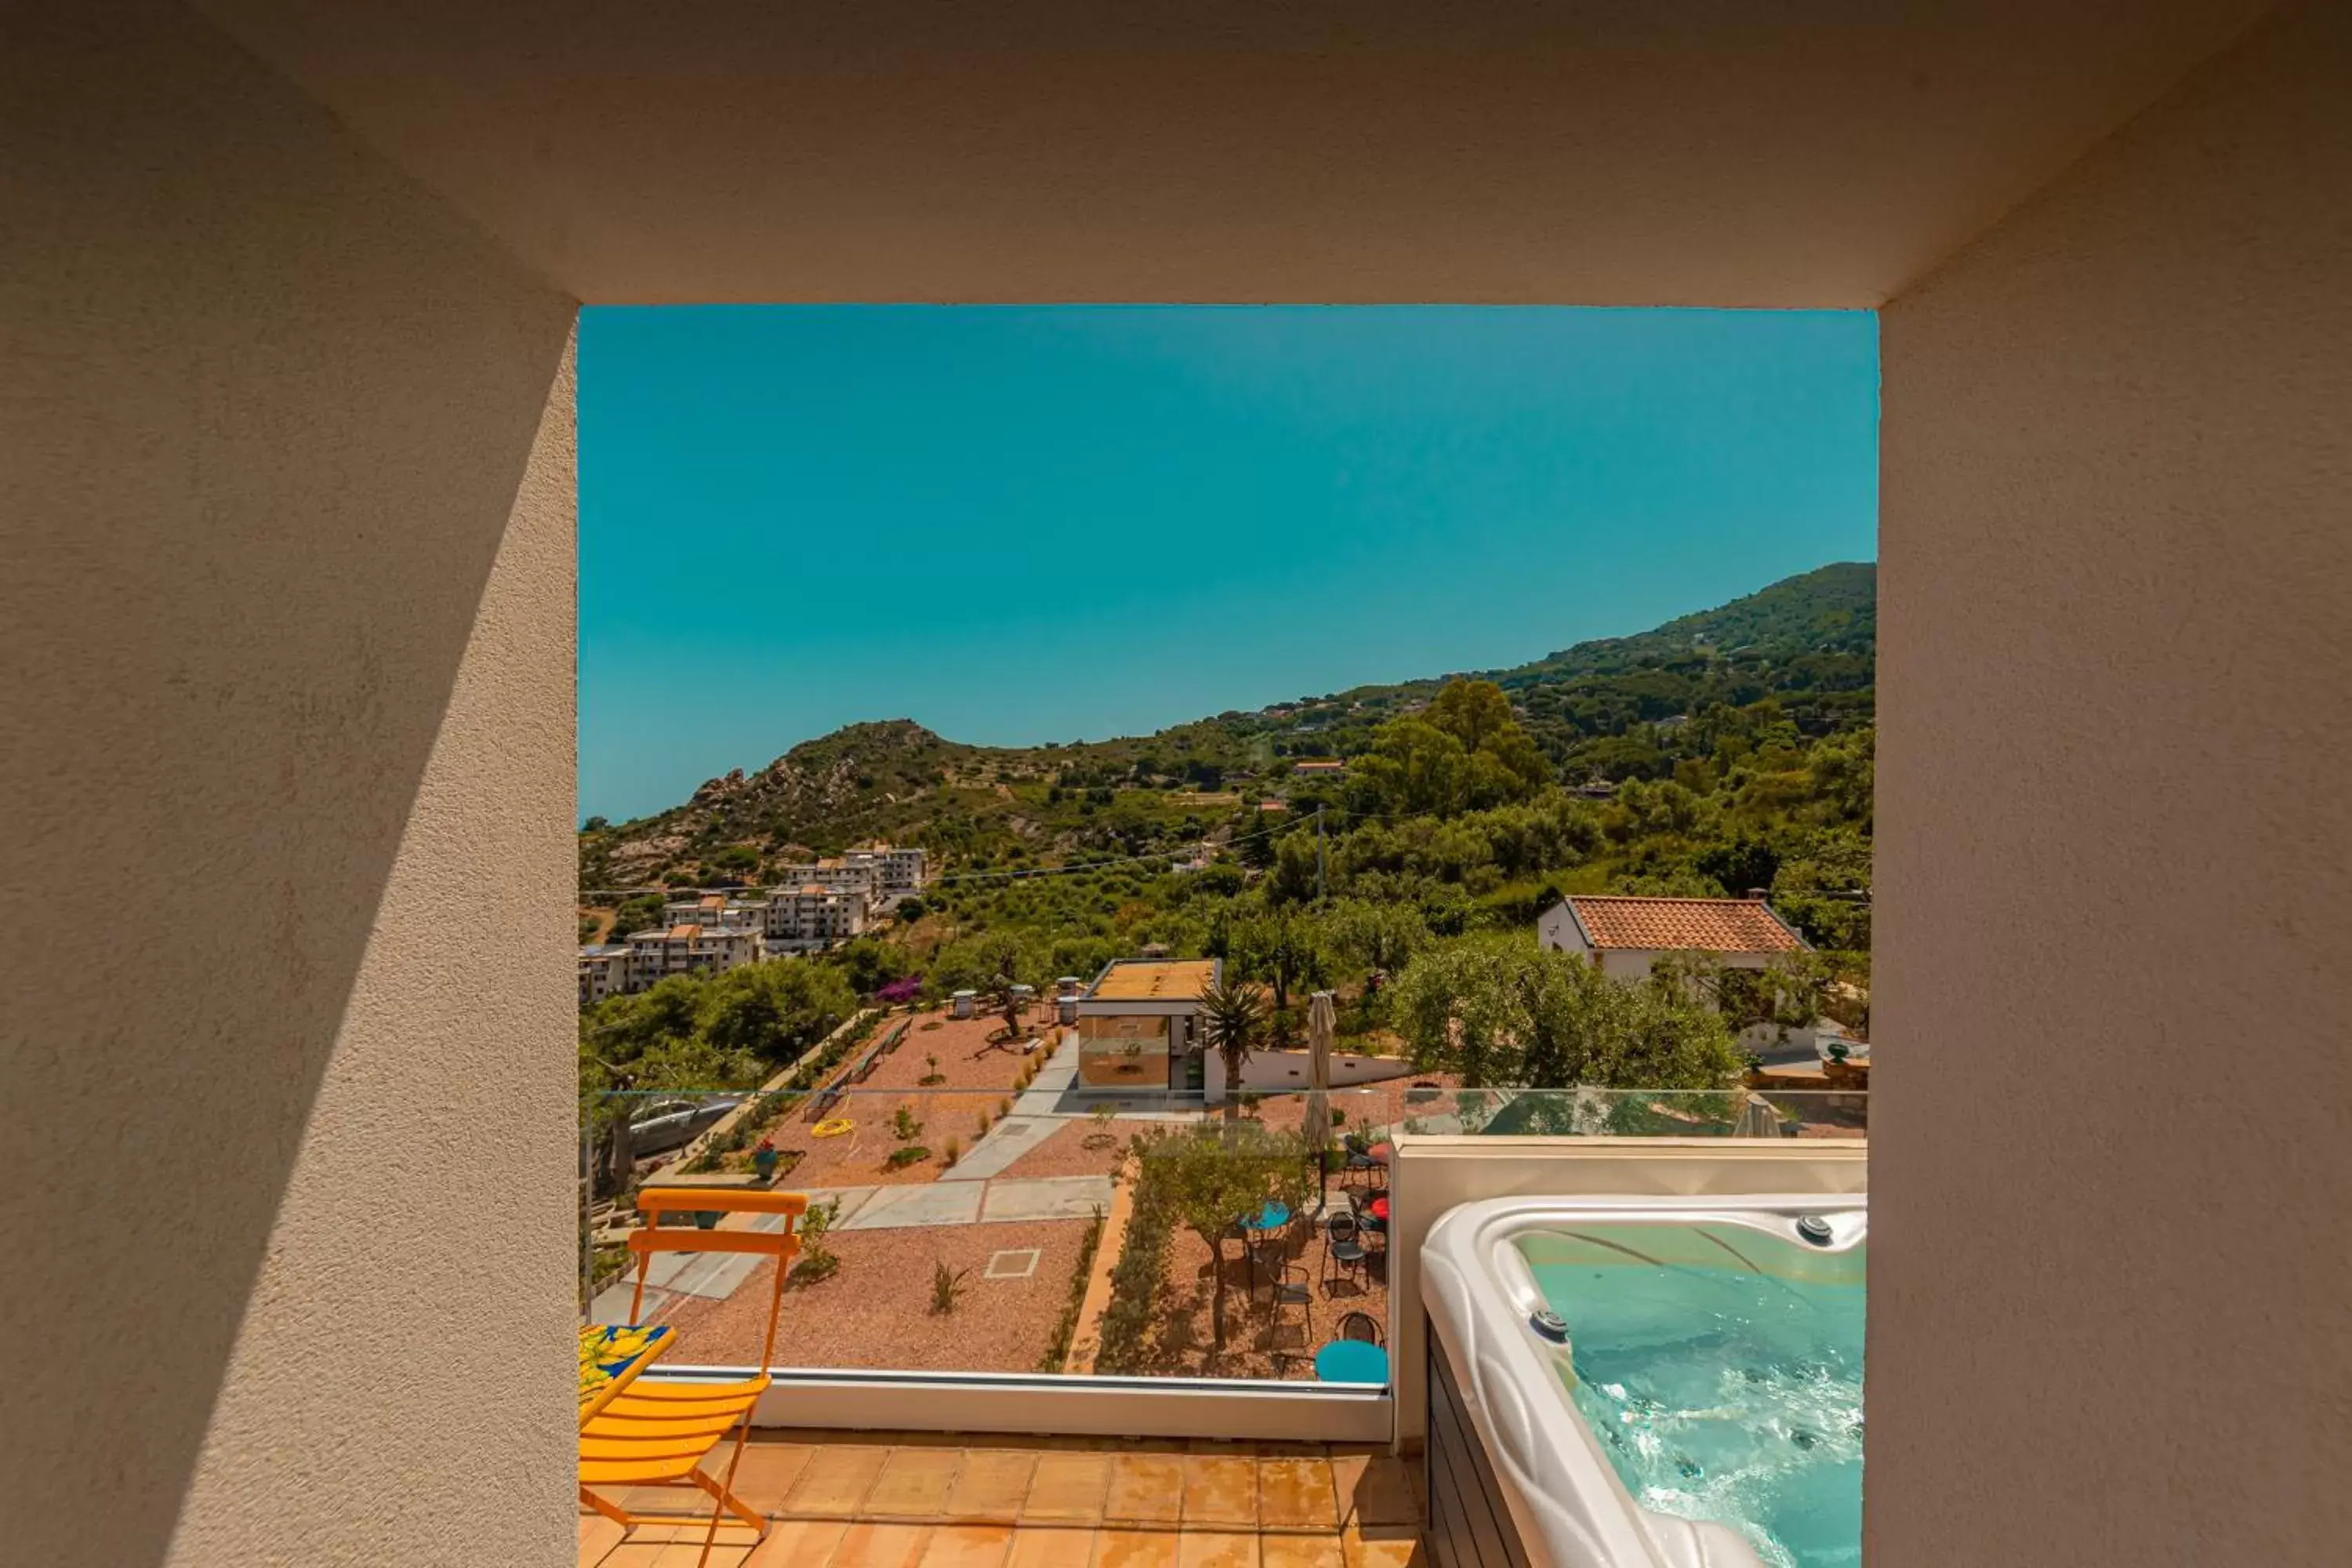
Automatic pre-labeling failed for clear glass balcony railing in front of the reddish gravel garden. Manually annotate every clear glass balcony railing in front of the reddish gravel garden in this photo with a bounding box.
[581,1020,1867,1382]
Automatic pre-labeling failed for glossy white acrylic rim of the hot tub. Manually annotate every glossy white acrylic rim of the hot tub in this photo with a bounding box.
[1421,1192,1870,1568]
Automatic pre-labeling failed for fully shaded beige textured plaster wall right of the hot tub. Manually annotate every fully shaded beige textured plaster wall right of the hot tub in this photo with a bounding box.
[1867,5,2352,1568]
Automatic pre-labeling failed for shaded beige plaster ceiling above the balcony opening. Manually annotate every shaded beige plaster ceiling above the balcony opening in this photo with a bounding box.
[200,0,2265,306]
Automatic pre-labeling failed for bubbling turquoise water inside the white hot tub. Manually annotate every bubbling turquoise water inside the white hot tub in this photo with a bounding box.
[1529,1227,1863,1568]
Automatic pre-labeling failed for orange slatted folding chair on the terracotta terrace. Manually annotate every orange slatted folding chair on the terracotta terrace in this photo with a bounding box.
[581,1187,809,1563]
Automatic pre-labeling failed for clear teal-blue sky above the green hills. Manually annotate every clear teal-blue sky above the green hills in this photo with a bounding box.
[579,306,1877,820]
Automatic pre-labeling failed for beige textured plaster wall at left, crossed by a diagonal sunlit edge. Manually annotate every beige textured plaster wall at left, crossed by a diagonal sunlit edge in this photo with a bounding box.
[0,2,574,1568]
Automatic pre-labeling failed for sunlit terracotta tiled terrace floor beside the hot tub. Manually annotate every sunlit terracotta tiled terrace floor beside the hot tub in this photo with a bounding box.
[579,1432,1428,1568]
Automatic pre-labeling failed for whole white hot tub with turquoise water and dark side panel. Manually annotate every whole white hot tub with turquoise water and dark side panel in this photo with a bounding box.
[1421,1194,1870,1568]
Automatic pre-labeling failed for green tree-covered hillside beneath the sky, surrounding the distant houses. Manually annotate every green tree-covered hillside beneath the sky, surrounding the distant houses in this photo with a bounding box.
[581,564,1877,1105]
